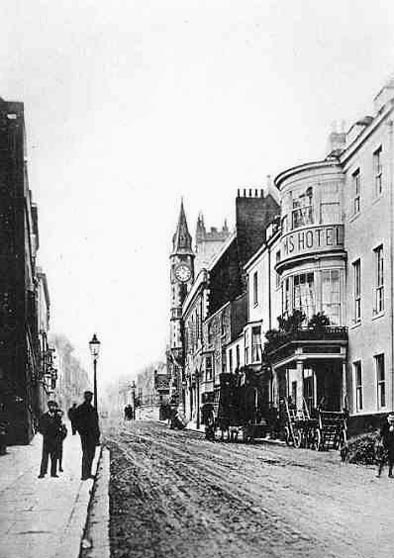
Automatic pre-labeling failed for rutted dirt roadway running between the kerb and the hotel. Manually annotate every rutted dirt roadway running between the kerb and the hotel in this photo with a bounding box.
[107,421,394,558]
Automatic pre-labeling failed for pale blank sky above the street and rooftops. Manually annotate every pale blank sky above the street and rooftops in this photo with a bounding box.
[0,0,394,390]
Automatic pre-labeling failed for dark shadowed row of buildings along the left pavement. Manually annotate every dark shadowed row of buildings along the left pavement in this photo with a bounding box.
[0,99,57,444]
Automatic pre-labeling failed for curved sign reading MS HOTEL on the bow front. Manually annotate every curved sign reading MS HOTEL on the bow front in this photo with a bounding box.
[280,225,344,263]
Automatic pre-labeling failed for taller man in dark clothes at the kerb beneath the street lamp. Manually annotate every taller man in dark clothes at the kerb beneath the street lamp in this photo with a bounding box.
[74,391,100,480]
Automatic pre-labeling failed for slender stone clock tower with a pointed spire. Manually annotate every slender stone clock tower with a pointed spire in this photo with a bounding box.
[168,201,194,404]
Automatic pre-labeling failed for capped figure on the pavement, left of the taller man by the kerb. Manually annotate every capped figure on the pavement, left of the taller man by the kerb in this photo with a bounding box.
[38,401,59,479]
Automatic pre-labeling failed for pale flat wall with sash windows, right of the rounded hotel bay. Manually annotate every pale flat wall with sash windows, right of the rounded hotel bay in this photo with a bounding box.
[343,105,394,424]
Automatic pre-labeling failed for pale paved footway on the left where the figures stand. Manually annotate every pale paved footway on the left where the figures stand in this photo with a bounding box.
[0,425,100,558]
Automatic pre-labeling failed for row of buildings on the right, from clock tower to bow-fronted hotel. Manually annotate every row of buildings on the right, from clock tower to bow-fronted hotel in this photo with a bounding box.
[167,77,394,438]
